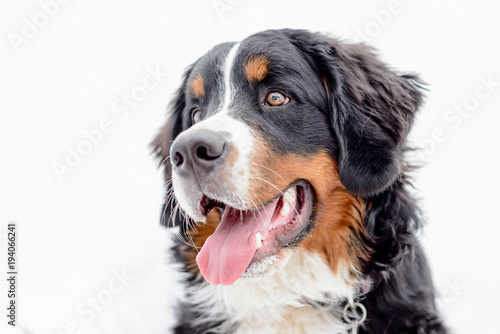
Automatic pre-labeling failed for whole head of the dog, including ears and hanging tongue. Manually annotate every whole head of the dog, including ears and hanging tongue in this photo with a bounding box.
[154,30,421,284]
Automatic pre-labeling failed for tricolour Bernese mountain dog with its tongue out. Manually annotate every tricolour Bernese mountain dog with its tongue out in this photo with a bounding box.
[152,29,448,334]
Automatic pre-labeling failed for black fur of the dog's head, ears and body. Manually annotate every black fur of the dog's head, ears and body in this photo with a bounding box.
[153,29,447,334]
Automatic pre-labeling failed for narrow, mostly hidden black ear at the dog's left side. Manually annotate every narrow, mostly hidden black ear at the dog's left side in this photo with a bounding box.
[151,68,191,227]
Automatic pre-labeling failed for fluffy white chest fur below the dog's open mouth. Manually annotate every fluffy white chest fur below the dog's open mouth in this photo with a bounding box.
[189,250,355,334]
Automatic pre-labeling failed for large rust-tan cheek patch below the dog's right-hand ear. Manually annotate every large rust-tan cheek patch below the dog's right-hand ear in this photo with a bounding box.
[250,139,370,276]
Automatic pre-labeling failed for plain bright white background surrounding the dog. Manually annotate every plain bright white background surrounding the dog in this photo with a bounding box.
[0,0,500,334]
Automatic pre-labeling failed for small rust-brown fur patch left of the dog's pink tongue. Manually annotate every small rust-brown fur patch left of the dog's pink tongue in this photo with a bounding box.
[182,209,221,275]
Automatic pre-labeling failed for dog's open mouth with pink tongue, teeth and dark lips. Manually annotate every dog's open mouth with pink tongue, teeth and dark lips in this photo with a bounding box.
[196,181,313,285]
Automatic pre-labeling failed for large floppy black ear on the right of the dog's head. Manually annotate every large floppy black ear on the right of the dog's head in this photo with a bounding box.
[320,39,423,197]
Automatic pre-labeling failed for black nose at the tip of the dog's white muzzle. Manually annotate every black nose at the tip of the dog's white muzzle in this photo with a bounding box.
[170,130,227,177]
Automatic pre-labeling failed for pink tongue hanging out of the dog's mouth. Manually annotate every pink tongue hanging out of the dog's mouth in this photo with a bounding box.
[196,200,278,285]
